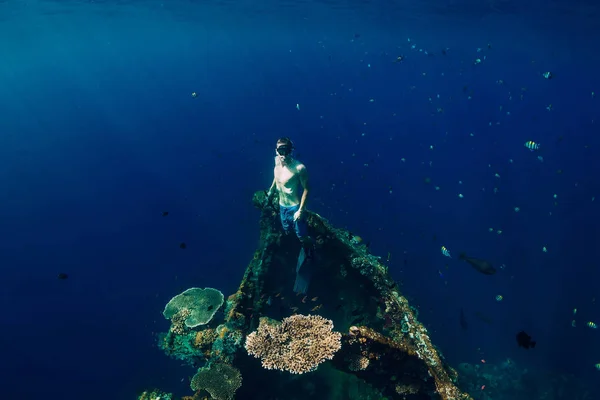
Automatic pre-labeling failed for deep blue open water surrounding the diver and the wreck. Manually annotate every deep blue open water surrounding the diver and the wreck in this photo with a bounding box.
[0,0,600,400]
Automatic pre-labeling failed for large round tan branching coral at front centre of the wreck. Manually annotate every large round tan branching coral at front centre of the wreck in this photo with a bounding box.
[245,314,341,374]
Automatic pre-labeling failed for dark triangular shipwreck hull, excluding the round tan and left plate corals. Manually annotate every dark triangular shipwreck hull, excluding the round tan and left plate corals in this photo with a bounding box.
[159,192,471,400]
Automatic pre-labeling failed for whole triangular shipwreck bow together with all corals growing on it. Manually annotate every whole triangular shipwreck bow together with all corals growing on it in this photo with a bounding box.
[143,192,471,400]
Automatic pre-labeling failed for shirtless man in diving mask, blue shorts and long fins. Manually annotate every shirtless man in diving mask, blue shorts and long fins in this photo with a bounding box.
[267,137,313,293]
